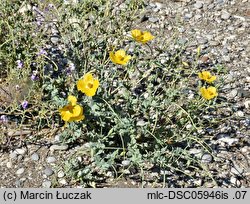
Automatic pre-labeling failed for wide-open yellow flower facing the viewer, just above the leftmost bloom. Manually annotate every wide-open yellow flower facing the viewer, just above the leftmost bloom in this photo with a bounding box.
[76,73,99,96]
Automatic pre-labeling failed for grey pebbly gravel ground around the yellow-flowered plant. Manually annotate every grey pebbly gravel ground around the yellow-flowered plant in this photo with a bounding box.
[0,0,250,187]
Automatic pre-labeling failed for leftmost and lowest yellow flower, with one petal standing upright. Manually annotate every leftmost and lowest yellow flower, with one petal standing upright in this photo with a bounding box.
[59,95,85,122]
